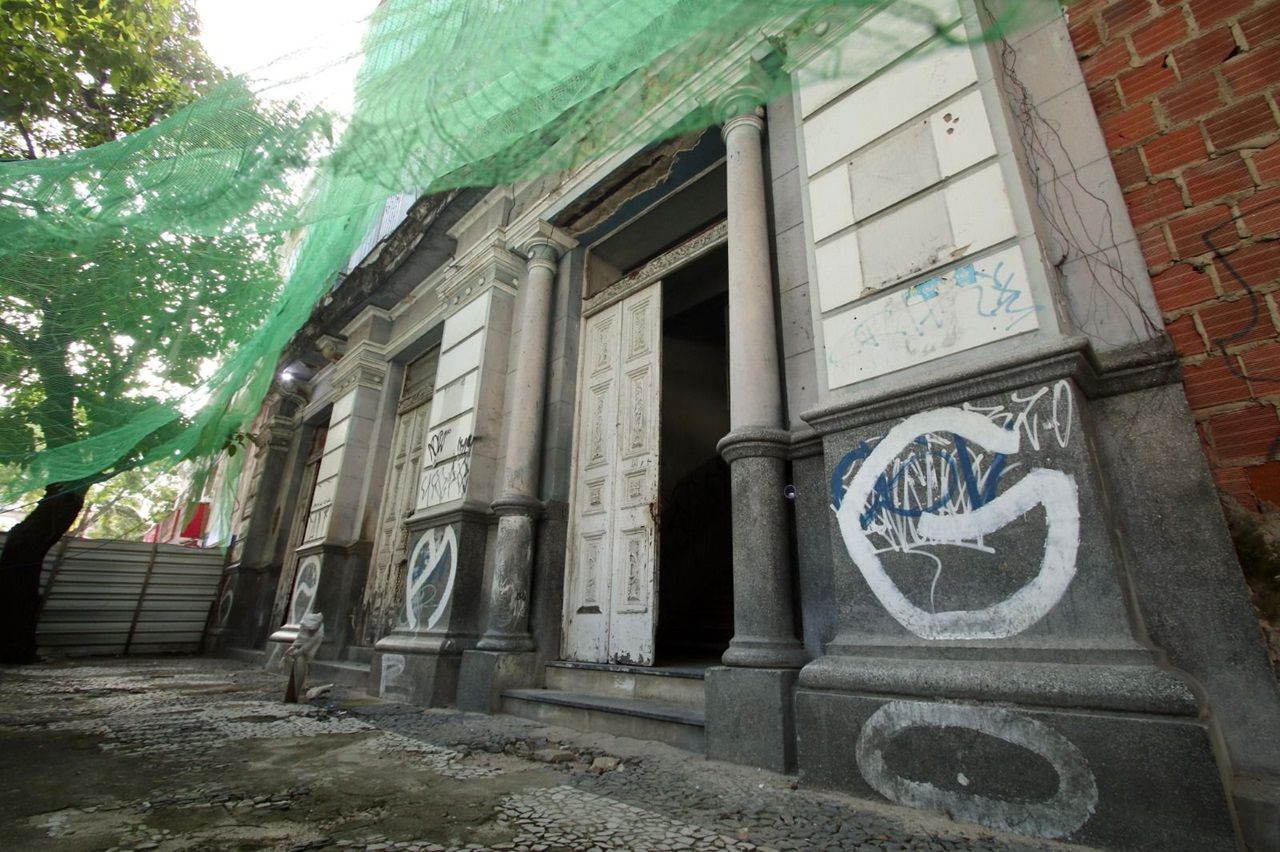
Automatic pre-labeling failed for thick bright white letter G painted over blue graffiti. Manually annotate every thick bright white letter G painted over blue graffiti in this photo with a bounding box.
[836,408,1080,640]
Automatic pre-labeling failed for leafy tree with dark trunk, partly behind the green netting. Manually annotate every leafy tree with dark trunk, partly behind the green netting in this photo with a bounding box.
[0,0,259,663]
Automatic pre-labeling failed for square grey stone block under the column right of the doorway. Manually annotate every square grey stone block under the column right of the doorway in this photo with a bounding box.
[704,667,799,773]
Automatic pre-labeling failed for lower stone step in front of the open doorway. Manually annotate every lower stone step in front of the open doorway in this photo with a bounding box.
[502,685,707,753]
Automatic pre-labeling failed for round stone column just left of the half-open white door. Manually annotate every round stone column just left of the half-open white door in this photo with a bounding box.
[479,235,562,651]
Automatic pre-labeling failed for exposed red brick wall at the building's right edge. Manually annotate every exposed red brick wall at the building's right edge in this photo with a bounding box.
[1069,0,1280,509]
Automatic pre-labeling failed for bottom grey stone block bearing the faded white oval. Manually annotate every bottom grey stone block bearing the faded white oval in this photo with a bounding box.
[795,688,1236,852]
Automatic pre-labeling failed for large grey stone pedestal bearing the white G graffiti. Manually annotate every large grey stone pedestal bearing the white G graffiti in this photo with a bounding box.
[795,347,1236,852]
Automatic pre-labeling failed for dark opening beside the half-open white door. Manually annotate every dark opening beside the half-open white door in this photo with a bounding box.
[655,248,733,665]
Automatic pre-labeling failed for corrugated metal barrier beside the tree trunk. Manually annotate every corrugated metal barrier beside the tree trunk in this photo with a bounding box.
[0,533,225,655]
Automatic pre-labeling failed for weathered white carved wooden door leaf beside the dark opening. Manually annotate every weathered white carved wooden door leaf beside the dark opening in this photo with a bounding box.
[563,281,662,665]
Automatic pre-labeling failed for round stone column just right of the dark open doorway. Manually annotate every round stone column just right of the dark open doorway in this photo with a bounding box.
[717,101,806,668]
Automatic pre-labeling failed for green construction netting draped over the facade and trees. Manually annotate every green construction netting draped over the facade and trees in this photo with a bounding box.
[0,0,1059,500]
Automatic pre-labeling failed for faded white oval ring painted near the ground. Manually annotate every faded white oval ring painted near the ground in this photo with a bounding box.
[856,701,1098,837]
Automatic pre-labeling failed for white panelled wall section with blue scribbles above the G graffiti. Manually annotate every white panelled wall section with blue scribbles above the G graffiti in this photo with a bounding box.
[796,6,1055,391]
